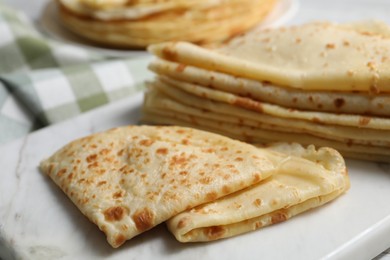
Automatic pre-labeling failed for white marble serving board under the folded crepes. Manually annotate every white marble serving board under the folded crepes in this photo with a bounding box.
[0,94,390,260]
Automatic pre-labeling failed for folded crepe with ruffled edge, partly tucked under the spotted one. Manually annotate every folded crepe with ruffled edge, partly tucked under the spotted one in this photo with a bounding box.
[167,144,350,242]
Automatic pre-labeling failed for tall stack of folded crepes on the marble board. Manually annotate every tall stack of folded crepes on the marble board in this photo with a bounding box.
[143,22,390,162]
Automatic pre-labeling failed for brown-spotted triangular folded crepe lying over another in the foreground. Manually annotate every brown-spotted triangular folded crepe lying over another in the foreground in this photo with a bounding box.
[40,126,276,247]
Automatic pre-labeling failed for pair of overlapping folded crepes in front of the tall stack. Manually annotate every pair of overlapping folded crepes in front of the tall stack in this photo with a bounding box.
[41,126,349,247]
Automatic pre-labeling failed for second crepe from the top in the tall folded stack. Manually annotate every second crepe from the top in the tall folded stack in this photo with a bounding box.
[149,59,390,116]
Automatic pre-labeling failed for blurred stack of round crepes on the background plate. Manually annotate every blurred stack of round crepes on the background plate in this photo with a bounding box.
[57,0,276,47]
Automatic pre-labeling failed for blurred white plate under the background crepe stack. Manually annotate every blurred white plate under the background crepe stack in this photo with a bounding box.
[38,0,298,57]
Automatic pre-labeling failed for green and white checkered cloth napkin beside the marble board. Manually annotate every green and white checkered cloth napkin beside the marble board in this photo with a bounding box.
[0,1,151,144]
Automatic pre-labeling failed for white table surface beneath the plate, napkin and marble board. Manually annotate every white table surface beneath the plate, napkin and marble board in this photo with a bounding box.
[0,0,390,260]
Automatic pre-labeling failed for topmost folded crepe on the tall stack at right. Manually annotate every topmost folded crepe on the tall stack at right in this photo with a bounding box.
[149,23,390,93]
